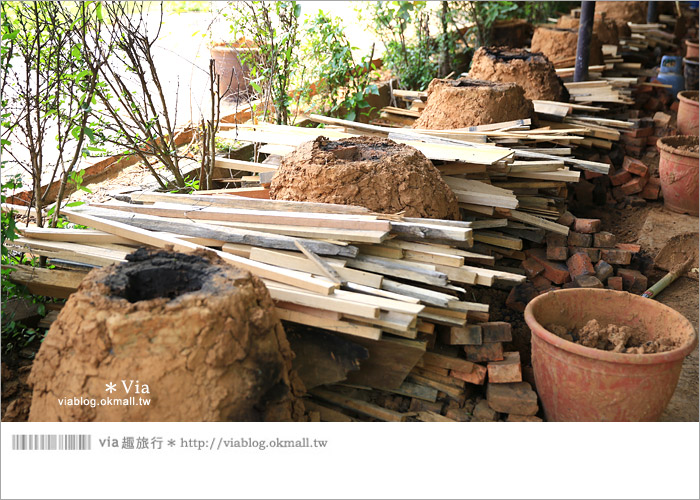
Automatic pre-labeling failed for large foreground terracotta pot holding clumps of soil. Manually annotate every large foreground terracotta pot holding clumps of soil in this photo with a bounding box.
[525,288,697,422]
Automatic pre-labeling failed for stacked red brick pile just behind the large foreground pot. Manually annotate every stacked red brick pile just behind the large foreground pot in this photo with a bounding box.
[506,211,647,312]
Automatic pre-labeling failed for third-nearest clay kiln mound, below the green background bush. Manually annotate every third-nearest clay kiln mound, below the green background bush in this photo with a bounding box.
[413,78,535,130]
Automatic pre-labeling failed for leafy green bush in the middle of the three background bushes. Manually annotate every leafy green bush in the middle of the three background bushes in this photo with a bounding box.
[302,10,379,120]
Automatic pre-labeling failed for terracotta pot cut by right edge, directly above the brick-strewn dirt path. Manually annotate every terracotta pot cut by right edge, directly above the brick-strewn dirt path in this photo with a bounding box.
[656,135,700,217]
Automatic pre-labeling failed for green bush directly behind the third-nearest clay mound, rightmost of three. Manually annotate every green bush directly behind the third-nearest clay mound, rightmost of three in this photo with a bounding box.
[359,1,439,90]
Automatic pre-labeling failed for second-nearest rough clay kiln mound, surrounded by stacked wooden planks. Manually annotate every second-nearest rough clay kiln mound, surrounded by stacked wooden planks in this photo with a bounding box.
[270,137,459,219]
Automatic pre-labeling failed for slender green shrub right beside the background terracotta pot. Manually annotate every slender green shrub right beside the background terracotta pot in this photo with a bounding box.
[224,1,303,125]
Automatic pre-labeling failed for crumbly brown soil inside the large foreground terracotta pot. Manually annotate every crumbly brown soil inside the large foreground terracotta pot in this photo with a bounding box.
[547,319,679,354]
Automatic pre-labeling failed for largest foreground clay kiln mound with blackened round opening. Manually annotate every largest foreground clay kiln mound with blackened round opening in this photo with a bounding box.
[29,249,304,422]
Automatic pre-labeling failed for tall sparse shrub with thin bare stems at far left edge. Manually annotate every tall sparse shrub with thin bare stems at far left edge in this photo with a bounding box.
[1,1,106,227]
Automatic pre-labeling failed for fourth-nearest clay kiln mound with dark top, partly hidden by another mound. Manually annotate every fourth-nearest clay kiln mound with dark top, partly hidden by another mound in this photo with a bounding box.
[469,47,569,102]
